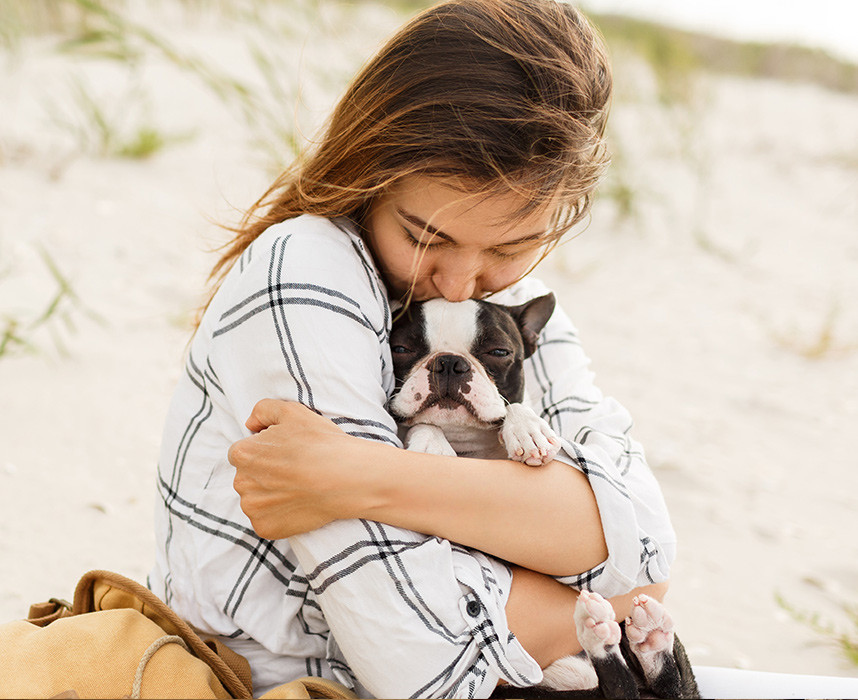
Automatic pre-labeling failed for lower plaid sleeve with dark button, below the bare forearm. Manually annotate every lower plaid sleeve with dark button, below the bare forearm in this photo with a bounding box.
[291,520,542,698]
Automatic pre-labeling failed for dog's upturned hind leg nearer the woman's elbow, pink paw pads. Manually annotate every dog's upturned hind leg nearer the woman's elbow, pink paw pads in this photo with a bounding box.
[575,591,639,698]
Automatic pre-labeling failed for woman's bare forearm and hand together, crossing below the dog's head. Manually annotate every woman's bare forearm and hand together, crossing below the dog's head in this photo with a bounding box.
[229,400,607,575]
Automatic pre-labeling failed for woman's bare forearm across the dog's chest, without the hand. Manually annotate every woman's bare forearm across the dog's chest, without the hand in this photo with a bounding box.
[352,441,608,576]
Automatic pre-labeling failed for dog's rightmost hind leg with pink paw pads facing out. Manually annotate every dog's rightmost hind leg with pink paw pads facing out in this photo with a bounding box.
[626,595,682,698]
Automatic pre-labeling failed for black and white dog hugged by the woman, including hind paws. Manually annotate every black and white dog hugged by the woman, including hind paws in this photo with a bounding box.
[389,294,693,698]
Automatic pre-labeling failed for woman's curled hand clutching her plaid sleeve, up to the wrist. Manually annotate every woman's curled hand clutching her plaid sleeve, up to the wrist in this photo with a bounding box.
[228,399,360,540]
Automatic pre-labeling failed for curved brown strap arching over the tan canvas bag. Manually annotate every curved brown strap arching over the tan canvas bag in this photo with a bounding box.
[73,570,253,698]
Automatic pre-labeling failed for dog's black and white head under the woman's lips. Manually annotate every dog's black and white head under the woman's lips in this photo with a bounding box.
[389,294,555,427]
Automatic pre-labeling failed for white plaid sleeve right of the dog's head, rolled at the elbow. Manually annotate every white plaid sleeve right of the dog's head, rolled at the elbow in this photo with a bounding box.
[488,279,676,597]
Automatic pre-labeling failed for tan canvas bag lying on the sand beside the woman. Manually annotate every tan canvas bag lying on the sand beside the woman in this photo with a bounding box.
[0,571,355,699]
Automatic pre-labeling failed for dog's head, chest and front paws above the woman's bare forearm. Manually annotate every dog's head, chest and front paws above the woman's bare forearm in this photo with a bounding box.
[389,294,560,466]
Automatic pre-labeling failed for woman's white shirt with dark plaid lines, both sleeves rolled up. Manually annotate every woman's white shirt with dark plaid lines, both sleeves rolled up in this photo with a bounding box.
[149,216,675,697]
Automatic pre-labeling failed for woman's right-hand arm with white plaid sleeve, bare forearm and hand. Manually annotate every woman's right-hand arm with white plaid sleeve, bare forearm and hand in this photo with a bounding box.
[232,283,674,596]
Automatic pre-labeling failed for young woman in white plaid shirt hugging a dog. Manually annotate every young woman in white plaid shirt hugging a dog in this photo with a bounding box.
[149,0,675,697]
